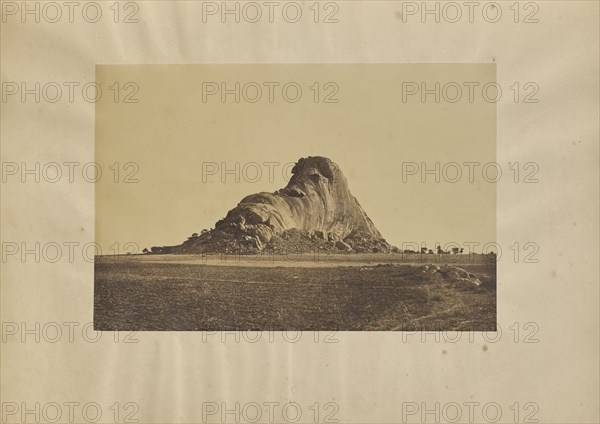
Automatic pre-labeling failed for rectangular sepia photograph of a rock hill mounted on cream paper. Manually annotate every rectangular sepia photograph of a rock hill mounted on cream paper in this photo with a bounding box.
[94,64,502,331]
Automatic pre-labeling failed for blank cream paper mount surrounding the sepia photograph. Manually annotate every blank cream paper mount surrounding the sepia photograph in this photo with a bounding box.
[1,1,599,423]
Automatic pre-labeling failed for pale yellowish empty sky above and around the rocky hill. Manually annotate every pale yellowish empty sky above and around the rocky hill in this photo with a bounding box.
[96,64,496,251]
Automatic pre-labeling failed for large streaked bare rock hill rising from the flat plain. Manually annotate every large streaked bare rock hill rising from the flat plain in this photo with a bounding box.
[176,156,391,253]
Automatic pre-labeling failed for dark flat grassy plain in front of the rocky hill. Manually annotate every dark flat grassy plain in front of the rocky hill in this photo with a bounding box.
[94,254,496,331]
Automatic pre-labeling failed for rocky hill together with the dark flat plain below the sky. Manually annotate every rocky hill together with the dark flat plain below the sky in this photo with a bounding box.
[94,156,496,331]
